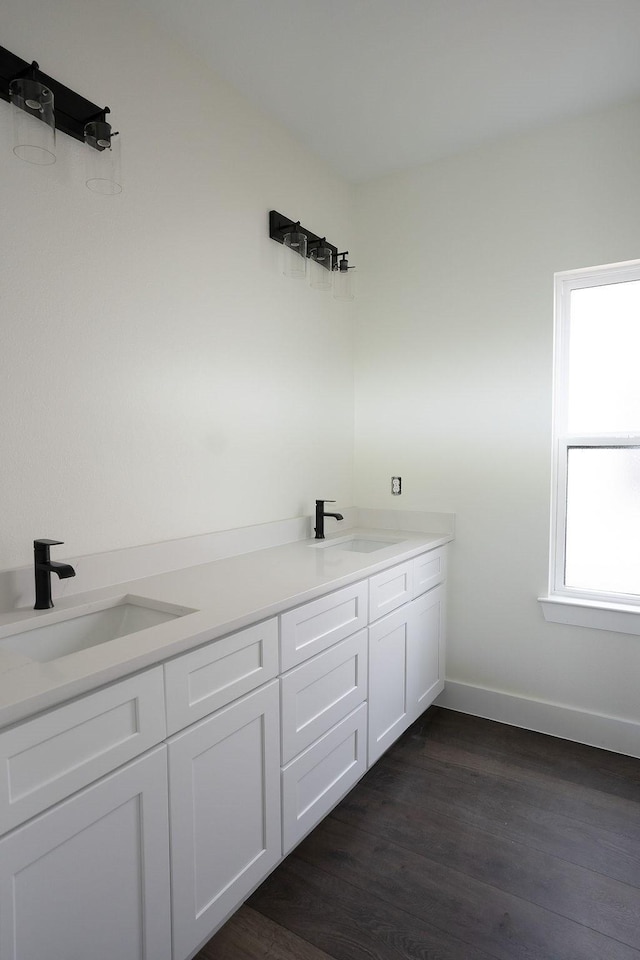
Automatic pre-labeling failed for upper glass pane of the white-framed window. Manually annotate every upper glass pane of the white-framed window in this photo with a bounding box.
[568,280,640,436]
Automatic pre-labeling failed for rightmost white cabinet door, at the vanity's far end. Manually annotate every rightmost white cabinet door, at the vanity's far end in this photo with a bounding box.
[407,586,445,722]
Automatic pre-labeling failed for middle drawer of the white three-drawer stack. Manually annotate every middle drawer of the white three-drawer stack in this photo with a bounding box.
[280,630,367,763]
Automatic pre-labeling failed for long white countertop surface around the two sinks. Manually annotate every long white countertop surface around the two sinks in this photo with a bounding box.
[0,529,453,727]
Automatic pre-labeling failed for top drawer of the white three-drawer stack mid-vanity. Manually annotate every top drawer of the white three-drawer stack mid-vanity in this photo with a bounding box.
[280,581,367,670]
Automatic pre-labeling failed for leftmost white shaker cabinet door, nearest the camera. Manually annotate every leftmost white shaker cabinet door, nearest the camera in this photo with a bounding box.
[0,746,171,960]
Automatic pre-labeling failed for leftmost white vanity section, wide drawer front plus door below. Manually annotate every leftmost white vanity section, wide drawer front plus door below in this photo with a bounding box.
[0,668,171,960]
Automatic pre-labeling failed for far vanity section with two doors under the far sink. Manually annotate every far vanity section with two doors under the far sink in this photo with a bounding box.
[368,547,446,766]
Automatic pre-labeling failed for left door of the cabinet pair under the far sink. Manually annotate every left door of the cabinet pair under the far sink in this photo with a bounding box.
[368,603,412,766]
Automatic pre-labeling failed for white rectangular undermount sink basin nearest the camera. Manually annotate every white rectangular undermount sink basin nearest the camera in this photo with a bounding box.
[0,596,194,663]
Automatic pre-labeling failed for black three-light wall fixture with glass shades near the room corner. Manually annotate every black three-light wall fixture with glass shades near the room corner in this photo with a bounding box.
[269,210,354,300]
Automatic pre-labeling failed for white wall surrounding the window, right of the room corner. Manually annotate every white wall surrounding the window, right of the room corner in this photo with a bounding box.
[355,103,640,746]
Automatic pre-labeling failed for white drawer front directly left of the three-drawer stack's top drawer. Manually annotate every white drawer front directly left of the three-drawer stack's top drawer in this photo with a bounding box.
[164,617,278,735]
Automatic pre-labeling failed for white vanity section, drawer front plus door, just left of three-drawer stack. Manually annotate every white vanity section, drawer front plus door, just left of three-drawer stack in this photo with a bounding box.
[165,620,281,960]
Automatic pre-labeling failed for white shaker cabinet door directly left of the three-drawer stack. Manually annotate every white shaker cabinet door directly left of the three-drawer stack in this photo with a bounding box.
[169,680,281,960]
